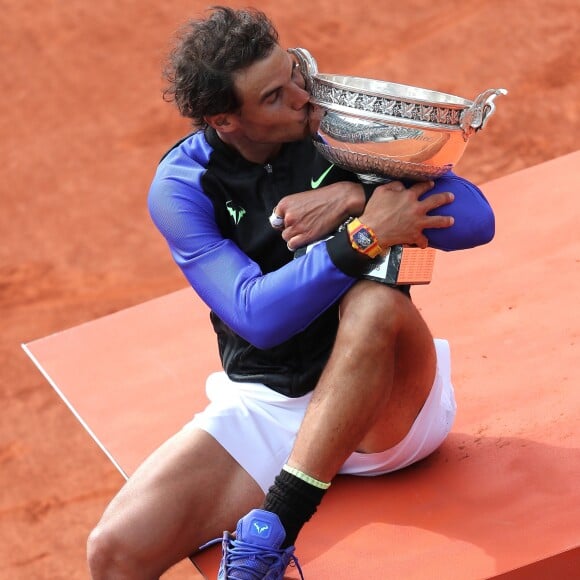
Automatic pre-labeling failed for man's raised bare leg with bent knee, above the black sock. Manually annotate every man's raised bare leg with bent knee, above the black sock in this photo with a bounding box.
[288,281,436,481]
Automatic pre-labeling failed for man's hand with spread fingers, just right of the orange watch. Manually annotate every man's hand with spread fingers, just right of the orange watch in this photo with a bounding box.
[360,181,454,248]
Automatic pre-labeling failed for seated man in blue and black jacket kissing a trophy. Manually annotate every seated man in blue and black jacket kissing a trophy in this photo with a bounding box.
[88,7,493,579]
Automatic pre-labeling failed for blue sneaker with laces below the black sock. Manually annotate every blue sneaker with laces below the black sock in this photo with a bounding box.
[218,510,304,580]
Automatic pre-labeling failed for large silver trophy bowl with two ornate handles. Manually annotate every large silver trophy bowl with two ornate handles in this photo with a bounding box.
[289,48,507,183]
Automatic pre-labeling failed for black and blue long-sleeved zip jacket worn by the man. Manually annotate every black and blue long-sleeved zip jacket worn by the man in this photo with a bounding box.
[148,128,494,397]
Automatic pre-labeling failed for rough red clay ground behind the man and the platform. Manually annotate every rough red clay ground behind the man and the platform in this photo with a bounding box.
[0,0,580,580]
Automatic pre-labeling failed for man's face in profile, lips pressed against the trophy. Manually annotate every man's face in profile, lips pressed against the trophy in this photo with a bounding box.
[234,46,310,144]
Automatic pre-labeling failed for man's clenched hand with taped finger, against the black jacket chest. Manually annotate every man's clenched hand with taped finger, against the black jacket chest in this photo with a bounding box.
[274,181,365,250]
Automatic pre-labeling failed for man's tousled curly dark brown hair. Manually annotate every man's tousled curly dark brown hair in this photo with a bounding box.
[163,6,278,126]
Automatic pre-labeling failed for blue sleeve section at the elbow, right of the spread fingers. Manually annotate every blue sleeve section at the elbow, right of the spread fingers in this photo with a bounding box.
[422,172,495,251]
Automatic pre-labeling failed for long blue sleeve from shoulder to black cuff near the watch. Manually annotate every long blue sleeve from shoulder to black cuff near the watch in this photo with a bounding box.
[148,177,356,349]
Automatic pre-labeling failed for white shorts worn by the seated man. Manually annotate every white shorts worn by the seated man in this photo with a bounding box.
[185,339,456,493]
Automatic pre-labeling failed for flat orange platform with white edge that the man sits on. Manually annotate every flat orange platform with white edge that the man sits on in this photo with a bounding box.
[24,151,580,580]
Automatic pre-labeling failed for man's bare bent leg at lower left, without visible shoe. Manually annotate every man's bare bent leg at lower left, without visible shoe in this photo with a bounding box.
[88,429,264,580]
